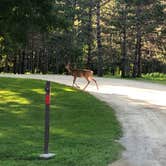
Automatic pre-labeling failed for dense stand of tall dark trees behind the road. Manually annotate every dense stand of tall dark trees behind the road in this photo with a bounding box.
[0,0,166,77]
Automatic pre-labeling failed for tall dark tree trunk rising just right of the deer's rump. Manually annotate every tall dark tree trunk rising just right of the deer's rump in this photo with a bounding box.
[96,0,103,76]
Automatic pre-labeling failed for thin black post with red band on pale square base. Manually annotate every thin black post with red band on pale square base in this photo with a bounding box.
[40,81,55,159]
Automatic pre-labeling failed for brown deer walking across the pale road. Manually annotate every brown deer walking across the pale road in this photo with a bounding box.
[65,63,99,90]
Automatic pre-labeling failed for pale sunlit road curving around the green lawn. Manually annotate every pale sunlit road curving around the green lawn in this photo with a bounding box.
[0,75,166,166]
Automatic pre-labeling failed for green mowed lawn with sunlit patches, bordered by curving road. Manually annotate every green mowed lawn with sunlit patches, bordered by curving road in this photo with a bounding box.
[0,78,123,166]
